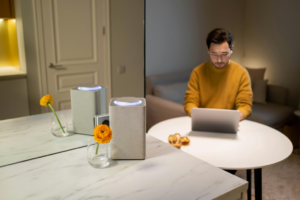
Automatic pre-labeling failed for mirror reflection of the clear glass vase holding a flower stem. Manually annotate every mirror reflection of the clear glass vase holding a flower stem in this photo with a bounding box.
[51,113,70,137]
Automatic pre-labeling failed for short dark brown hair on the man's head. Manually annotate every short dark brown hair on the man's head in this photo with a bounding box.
[206,28,233,49]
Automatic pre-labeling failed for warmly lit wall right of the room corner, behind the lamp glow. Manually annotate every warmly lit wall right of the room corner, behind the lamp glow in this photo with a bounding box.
[242,0,300,108]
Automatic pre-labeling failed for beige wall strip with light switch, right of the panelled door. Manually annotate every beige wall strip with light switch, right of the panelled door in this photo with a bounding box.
[110,0,144,97]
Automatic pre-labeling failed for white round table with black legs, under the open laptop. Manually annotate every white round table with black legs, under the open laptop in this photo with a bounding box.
[148,117,293,199]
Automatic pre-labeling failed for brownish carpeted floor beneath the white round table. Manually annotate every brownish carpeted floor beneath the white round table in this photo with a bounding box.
[236,153,300,200]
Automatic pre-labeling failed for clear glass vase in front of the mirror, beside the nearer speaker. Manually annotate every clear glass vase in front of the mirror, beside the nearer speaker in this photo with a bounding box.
[87,138,109,168]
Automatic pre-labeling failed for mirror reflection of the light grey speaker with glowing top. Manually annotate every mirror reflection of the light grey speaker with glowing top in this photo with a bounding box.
[71,86,107,135]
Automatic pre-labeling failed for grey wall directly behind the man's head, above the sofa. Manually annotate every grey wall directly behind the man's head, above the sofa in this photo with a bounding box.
[146,0,245,76]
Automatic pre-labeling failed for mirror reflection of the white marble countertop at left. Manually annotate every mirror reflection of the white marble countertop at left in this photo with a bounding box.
[0,110,90,166]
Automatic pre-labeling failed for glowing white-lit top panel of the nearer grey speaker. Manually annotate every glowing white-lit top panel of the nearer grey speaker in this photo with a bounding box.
[109,97,146,107]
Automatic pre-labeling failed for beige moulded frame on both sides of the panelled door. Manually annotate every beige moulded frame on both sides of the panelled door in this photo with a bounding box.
[22,0,112,115]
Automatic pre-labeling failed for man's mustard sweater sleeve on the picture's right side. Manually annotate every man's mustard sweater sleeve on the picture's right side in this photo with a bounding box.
[235,71,253,120]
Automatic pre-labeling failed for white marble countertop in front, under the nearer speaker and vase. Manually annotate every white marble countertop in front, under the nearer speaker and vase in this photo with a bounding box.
[0,135,248,200]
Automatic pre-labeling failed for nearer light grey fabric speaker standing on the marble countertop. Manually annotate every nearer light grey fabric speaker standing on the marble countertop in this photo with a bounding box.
[109,97,146,159]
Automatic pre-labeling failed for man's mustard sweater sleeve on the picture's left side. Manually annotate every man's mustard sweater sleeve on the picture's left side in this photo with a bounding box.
[184,69,200,116]
